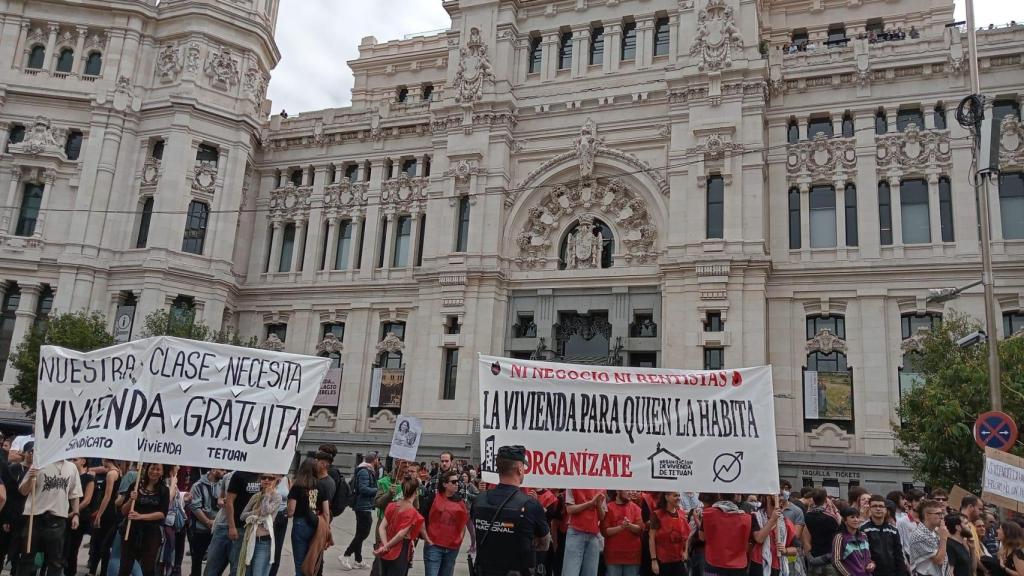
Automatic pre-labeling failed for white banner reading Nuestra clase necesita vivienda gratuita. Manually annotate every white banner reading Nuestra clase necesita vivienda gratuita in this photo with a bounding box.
[36,336,331,474]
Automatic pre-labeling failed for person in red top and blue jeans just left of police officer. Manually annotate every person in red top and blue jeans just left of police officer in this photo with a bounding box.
[420,470,476,576]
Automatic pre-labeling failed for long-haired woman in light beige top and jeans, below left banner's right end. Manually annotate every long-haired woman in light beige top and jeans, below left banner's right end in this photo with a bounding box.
[229,474,280,576]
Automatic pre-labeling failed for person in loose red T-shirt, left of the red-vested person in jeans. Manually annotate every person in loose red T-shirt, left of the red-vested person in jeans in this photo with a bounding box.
[374,478,423,576]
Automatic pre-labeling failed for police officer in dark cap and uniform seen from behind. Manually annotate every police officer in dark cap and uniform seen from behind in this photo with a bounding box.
[471,446,551,576]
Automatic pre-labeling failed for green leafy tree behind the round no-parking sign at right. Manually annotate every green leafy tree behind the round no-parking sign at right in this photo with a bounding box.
[896,312,1024,493]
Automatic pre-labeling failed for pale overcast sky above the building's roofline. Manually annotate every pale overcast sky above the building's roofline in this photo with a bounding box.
[268,0,1024,115]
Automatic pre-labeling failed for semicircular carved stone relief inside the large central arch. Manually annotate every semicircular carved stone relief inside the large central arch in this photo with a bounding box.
[515,178,657,269]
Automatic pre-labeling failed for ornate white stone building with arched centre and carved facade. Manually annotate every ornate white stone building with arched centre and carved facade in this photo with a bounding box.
[0,0,1024,493]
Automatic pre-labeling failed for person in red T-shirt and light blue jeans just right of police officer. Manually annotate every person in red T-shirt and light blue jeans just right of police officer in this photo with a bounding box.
[561,488,607,576]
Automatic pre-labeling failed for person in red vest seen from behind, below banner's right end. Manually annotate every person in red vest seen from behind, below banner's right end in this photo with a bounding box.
[699,494,753,576]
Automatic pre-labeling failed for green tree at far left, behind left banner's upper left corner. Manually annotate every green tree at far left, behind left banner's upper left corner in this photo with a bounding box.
[10,312,114,415]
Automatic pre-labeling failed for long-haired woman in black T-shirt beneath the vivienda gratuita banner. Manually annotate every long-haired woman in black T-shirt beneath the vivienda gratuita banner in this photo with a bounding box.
[118,463,171,576]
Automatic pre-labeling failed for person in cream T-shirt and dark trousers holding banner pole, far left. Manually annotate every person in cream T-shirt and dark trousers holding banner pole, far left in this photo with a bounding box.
[16,443,82,576]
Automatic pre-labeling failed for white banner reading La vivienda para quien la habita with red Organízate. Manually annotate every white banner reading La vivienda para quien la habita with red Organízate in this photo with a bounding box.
[479,356,778,494]
